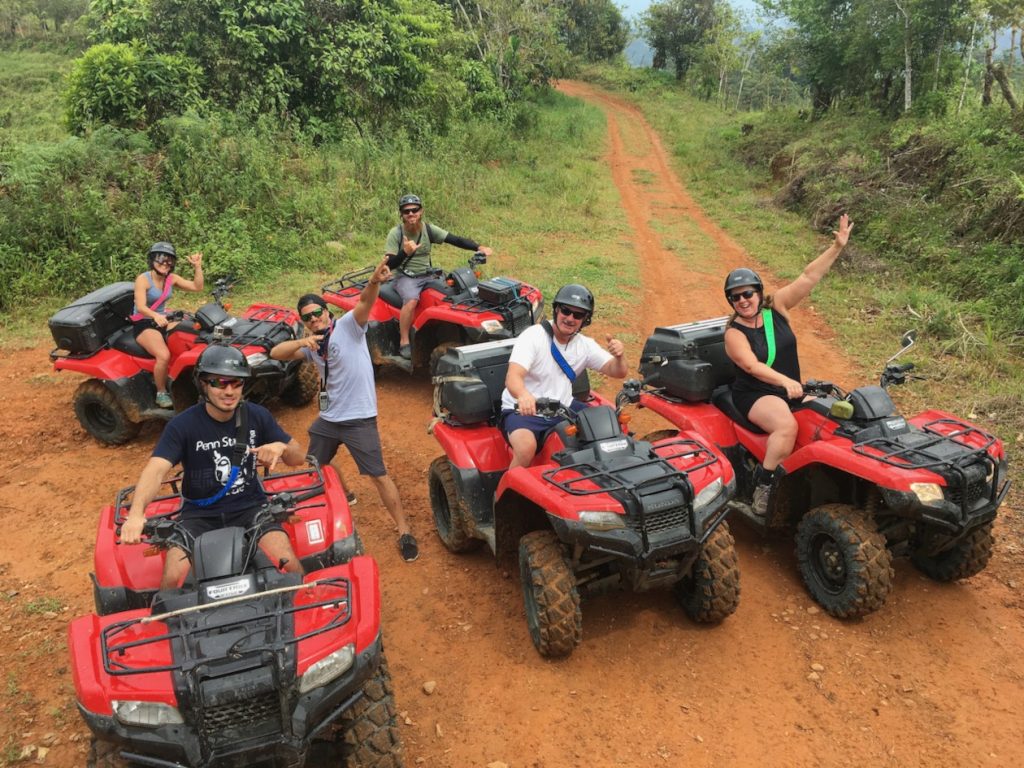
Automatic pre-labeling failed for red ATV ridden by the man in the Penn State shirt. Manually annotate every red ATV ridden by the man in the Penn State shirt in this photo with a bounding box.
[69,465,402,768]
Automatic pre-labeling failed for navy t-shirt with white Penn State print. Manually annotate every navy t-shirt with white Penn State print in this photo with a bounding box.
[153,402,292,517]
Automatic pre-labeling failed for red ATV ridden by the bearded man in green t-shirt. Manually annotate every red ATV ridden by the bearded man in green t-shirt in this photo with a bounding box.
[324,253,544,374]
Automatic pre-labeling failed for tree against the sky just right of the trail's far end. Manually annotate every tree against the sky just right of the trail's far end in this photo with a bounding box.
[641,0,720,80]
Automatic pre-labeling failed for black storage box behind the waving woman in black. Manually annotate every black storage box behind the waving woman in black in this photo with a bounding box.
[640,317,735,402]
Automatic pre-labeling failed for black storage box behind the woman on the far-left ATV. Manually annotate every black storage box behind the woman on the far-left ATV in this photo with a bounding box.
[49,283,135,354]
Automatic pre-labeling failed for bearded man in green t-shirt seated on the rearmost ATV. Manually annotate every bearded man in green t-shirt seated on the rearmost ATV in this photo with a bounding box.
[384,195,490,359]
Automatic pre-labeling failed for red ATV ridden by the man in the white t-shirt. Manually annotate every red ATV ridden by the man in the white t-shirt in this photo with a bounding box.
[429,341,739,656]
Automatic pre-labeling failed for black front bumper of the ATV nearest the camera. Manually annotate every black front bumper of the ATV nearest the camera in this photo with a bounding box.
[79,635,382,768]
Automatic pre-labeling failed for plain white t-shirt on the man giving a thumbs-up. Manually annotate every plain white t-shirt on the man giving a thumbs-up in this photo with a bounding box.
[502,324,611,410]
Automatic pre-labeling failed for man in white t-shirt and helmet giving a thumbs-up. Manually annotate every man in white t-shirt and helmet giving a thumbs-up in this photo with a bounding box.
[501,284,628,469]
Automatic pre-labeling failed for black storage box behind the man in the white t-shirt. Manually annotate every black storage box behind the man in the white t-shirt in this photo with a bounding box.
[434,339,590,426]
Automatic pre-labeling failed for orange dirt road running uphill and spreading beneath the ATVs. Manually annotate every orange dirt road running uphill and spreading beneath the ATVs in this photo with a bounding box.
[0,83,1024,768]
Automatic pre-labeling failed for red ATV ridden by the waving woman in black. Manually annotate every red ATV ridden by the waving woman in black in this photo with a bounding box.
[640,317,1010,617]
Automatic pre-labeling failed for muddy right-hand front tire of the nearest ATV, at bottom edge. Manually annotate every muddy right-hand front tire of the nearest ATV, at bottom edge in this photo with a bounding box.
[339,654,403,768]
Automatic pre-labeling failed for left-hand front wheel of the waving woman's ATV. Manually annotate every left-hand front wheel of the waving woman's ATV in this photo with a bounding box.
[797,504,893,618]
